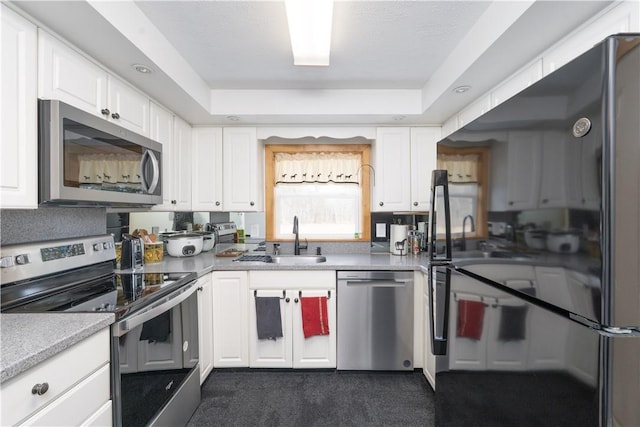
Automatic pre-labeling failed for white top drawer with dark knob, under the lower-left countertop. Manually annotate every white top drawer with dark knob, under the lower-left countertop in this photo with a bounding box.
[0,328,110,426]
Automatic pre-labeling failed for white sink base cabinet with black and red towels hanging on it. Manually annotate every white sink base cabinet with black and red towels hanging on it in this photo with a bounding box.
[249,271,336,369]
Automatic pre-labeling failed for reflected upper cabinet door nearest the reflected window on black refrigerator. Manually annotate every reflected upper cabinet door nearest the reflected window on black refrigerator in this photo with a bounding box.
[507,131,541,210]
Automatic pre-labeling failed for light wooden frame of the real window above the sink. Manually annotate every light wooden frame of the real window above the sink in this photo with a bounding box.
[264,144,371,242]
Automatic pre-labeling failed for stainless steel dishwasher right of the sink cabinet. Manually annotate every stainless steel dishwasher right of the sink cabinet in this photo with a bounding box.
[337,271,413,371]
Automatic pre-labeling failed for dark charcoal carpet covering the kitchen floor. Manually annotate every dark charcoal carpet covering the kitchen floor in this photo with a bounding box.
[188,369,434,427]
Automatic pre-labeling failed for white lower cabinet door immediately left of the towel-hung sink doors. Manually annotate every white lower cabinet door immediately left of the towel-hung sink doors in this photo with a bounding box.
[213,271,249,368]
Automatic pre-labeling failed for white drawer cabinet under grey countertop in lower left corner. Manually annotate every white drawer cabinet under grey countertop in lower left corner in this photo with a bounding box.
[0,328,112,426]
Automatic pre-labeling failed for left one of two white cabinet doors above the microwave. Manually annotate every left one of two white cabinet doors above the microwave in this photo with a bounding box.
[38,30,108,117]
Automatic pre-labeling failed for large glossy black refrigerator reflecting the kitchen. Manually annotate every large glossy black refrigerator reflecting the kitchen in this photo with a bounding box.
[428,34,640,427]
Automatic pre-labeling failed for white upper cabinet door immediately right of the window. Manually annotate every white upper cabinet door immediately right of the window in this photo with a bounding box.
[371,127,411,212]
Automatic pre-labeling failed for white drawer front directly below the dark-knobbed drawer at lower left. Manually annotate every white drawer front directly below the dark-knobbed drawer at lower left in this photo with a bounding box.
[22,363,111,427]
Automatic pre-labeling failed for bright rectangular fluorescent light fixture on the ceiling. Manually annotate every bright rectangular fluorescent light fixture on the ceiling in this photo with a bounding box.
[285,0,333,66]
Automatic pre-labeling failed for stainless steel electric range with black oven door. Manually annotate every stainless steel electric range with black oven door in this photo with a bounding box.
[0,235,200,426]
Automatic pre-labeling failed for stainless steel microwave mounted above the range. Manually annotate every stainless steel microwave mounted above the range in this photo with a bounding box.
[38,99,162,206]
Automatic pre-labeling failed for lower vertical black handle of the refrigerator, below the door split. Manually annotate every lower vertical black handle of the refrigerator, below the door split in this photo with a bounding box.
[428,266,451,356]
